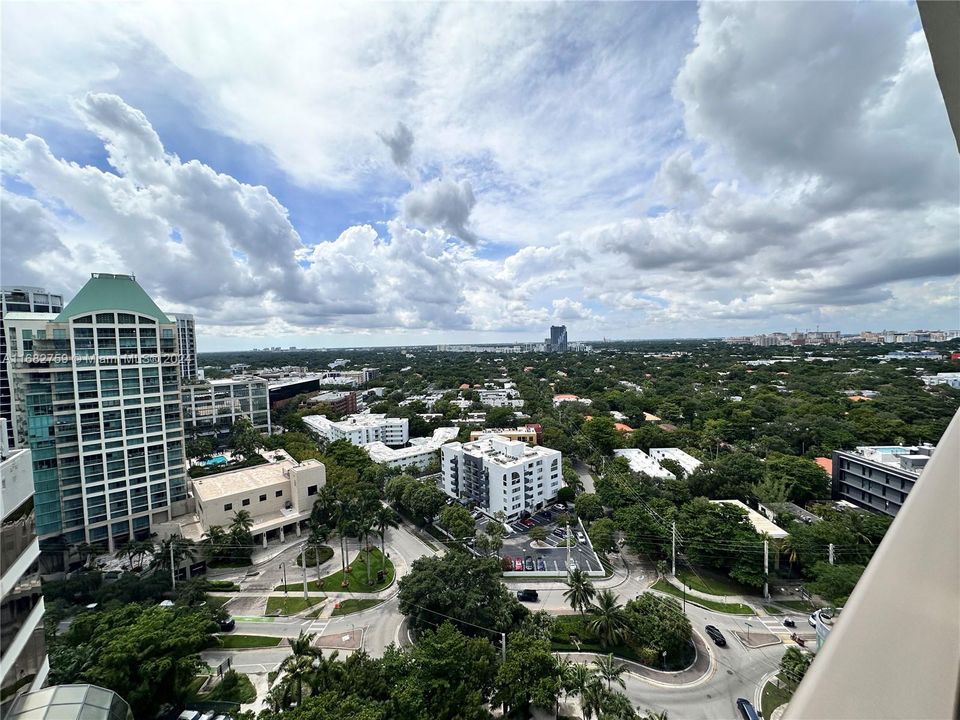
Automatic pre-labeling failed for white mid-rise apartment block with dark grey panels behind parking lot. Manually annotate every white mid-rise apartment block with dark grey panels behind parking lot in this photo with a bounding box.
[440,435,563,519]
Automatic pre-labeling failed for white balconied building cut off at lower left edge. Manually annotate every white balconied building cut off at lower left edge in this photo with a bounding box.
[0,420,49,704]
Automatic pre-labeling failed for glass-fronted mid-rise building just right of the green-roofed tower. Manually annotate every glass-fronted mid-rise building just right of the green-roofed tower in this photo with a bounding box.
[180,377,271,439]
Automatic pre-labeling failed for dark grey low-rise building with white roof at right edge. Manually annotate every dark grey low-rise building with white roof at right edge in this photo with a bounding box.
[833,445,935,516]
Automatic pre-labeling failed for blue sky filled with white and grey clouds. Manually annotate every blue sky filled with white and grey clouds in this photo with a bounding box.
[0,2,960,350]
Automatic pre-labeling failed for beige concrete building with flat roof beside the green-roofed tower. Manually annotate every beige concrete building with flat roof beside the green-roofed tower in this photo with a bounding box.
[160,450,327,547]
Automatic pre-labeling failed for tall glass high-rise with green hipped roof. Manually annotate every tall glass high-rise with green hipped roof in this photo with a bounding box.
[5,273,186,551]
